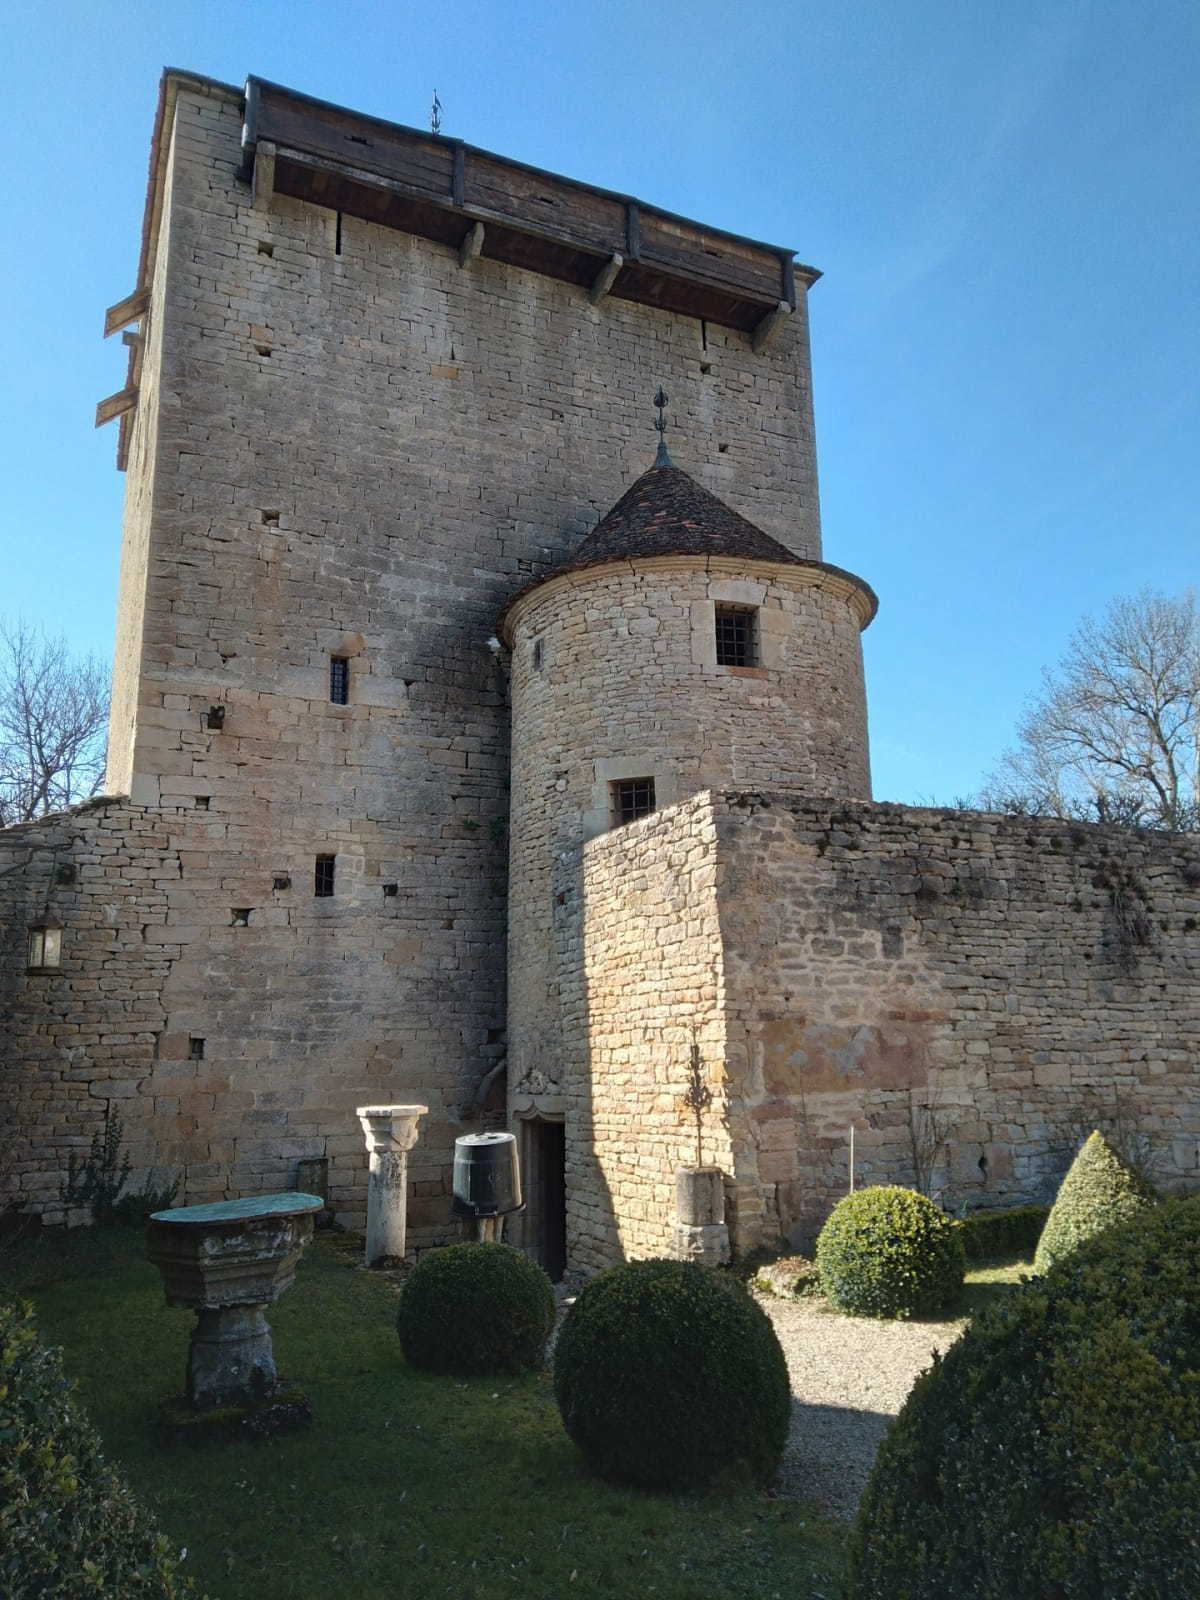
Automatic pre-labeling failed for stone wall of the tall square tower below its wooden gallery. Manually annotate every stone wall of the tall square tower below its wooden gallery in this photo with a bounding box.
[0,80,819,1222]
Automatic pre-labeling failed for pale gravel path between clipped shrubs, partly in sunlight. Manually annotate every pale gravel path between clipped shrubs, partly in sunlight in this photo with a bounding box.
[757,1294,966,1517]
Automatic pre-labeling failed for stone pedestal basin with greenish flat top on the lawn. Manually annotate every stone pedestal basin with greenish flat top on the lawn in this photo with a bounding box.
[146,1194,323,1411]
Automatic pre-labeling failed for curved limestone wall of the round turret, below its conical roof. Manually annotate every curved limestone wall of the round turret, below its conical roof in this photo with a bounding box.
[509,557,870,1145]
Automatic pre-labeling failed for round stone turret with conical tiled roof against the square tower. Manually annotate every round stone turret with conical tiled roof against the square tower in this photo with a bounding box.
[502,448,875,1267]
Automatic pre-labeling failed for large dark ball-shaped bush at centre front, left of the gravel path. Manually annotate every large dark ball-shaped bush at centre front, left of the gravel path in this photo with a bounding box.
[554,1261,792,1488]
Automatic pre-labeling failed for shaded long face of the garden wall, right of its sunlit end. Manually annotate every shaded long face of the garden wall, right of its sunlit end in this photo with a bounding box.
[714,794,1200,1248]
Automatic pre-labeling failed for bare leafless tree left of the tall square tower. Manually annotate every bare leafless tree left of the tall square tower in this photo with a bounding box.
[0,621,109,827]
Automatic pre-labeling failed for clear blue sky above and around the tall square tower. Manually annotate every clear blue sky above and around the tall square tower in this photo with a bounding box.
[0,0,1200,800]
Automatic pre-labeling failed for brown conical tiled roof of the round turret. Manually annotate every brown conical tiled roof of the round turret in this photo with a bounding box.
[554,462,811,576]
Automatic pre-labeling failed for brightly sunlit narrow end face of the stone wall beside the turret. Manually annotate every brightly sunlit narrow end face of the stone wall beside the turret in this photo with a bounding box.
[558,795,733,1267]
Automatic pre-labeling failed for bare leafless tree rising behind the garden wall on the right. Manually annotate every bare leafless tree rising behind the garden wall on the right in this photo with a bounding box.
[982,589,1200,830]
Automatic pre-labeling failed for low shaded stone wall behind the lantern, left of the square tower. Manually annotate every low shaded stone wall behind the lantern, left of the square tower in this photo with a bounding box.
[0,800,178,1222]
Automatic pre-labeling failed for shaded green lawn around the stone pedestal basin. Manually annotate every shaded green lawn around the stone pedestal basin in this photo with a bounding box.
[0,1229,846,1600]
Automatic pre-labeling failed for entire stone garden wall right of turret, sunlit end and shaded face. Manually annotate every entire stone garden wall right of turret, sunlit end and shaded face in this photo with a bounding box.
[563,792,1200,1259]
